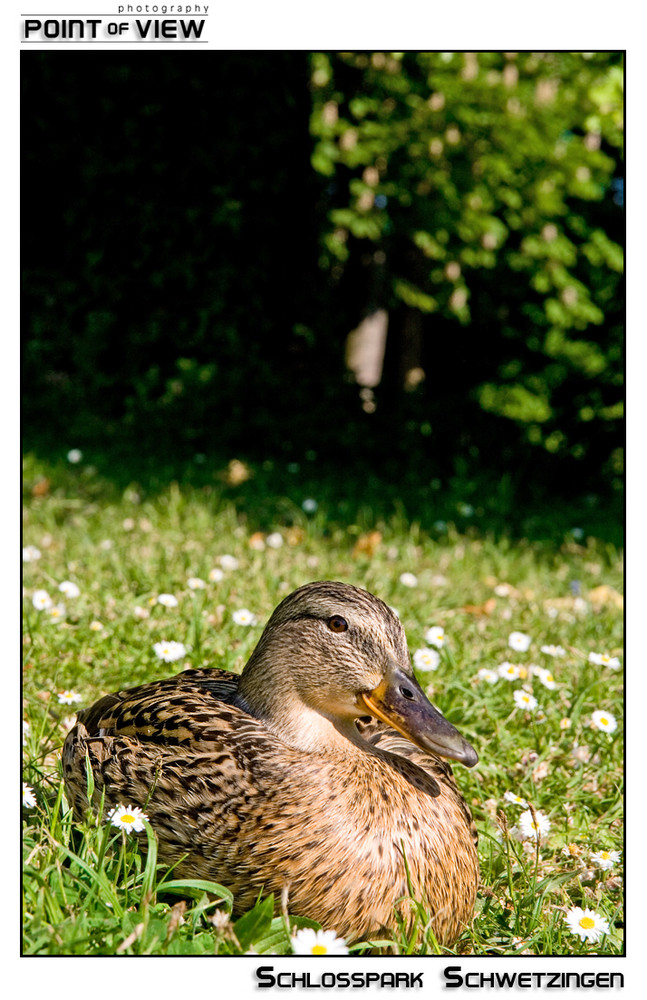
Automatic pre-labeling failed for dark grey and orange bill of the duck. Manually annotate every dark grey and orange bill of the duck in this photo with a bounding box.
[358,662,478,767]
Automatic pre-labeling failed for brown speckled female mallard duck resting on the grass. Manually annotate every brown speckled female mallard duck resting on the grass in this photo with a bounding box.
[63,581,479,944]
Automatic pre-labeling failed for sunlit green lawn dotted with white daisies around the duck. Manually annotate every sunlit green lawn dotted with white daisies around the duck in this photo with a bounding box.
[23,456,623,955]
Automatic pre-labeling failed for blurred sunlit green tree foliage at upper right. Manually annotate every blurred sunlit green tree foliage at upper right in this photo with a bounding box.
[311,52,623,482]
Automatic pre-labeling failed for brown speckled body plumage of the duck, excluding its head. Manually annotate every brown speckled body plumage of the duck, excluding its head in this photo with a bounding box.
[63,585,478,943]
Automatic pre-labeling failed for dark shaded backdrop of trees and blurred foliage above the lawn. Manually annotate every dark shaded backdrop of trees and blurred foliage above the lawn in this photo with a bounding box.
[22,52,623,498]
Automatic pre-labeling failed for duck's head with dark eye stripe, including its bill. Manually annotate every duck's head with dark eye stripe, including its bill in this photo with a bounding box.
[239,581,478,767]
